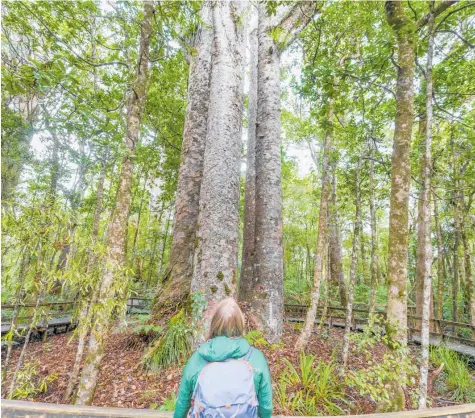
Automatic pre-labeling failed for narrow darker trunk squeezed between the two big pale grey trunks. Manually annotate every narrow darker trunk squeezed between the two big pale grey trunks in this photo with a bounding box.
[239,28,258,302]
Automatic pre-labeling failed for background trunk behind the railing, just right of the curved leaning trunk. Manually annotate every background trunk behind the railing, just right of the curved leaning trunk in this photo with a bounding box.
[328,171,347,306]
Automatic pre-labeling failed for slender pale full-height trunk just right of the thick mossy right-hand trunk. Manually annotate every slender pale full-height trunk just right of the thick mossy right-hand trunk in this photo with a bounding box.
[417,0,434,409]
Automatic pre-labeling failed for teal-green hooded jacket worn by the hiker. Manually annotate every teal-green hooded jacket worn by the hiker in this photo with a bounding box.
[173,336,272,418]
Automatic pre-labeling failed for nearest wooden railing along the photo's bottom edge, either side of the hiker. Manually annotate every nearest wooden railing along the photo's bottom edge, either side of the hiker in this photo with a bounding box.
[2,401,475,418]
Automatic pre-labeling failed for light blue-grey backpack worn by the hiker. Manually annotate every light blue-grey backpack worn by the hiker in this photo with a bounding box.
[190,348,258,418]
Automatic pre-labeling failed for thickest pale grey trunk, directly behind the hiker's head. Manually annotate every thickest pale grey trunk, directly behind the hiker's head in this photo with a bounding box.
[191,1,247,334]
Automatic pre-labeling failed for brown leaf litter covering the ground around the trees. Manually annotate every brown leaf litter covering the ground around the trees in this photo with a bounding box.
[4,324,460,414]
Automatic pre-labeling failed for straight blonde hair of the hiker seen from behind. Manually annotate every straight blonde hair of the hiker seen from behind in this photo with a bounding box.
[207,298,244,340]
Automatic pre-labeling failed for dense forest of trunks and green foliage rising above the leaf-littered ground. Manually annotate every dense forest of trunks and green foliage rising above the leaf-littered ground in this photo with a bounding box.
[1,0,475,412]
